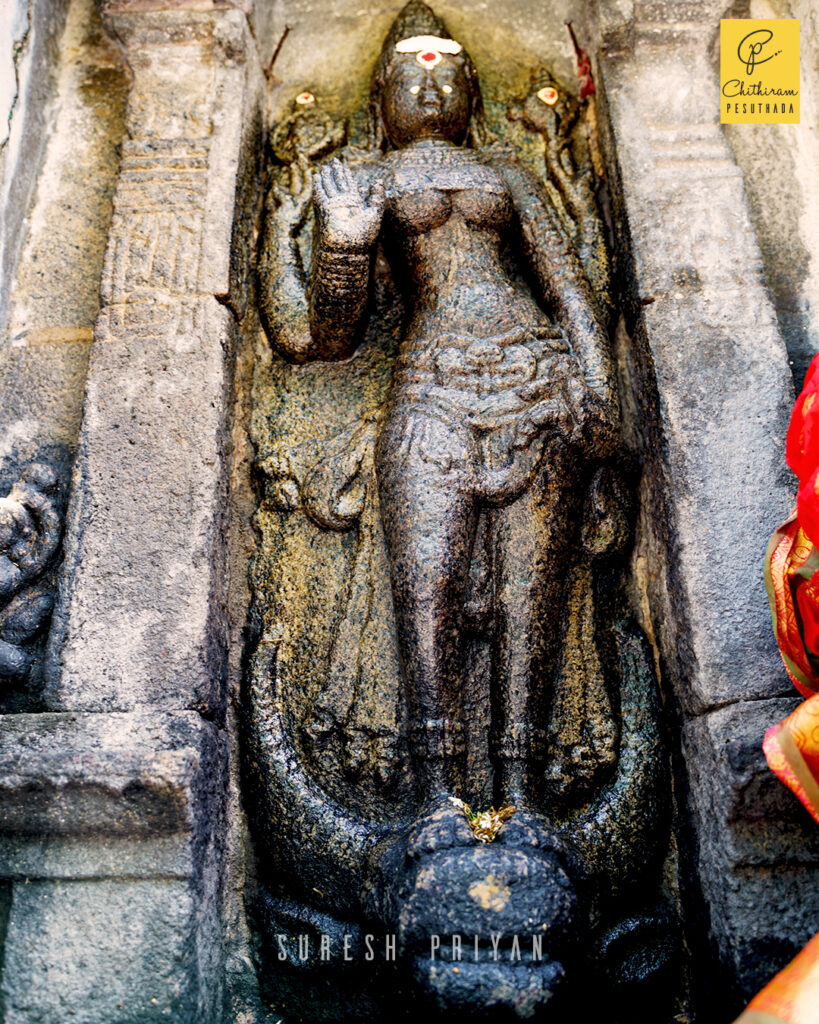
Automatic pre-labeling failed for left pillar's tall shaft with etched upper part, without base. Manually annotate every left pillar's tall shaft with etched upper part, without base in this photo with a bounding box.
[41,11,258,717]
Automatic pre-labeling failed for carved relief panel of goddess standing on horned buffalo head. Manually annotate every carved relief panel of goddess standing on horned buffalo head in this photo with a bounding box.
[242,0,685,1024]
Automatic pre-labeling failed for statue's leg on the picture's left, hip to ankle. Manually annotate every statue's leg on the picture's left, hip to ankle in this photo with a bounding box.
[377,404,477,799]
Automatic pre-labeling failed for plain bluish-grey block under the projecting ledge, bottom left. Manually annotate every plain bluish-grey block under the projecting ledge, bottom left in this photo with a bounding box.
[3,880,213,1024]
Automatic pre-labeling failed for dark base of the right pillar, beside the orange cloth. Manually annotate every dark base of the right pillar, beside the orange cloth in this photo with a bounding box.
[683,697,819,999]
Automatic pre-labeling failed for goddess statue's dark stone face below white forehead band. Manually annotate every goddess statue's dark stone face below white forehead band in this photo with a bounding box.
[382,53,472,147]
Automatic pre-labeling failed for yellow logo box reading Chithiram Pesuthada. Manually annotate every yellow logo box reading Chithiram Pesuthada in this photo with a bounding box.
[720,17,800,125]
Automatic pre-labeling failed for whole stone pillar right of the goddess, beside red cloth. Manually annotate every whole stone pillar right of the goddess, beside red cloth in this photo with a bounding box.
[597,2,819,1014]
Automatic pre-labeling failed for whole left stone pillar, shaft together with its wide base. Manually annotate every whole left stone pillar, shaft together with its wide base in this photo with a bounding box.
[0,3,261,1024]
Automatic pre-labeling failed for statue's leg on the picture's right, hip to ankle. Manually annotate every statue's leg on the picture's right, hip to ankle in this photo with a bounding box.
[493,446,581,805]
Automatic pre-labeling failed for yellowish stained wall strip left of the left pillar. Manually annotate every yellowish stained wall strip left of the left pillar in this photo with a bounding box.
[0,0,127,486]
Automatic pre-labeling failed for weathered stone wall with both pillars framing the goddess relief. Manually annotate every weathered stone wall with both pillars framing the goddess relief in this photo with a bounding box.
[0,0,819,1024]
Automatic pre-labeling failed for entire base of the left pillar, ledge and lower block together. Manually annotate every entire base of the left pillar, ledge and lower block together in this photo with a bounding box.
[0,712,226,1024]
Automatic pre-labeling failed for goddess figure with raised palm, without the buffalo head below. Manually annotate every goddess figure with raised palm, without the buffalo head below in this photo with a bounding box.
[259,4,616,847]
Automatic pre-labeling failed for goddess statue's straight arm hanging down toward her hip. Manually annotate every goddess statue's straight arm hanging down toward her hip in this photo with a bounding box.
[495,161,618,414]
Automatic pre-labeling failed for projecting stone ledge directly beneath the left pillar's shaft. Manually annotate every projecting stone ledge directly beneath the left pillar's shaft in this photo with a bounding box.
[0,712,224,843]
